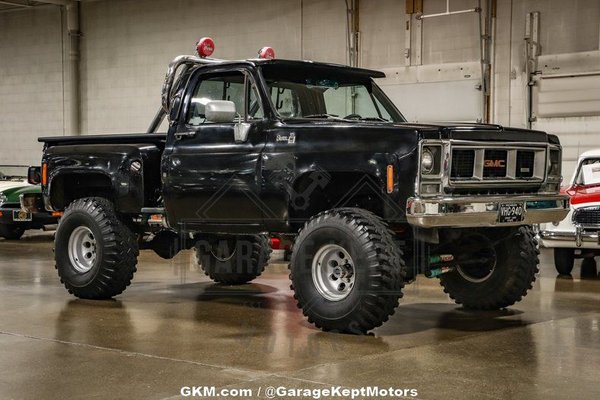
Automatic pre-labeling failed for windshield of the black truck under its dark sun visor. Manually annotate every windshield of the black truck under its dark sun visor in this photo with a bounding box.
[262,66,404,122]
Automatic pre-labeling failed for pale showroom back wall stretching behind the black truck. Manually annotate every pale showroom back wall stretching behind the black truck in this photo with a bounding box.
[0,0,600,178]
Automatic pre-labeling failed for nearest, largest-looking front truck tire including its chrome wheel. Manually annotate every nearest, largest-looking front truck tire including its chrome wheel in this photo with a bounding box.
[289,208,406,334]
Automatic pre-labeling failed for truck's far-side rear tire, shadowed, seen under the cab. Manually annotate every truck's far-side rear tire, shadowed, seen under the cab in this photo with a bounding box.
[195,235,272,285]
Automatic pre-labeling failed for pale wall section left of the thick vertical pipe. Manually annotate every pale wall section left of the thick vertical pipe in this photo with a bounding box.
[0,7,64,168]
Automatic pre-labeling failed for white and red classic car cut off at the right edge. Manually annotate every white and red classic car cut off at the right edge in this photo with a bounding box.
[539,149,600,275]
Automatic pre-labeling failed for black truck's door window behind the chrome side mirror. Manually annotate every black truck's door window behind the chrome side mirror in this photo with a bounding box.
[187,72,263,126]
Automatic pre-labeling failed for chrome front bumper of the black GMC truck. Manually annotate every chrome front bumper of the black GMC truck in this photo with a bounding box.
[406,195,569,228]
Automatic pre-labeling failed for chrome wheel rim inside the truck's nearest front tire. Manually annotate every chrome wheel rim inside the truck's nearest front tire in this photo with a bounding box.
[312,244,356,301]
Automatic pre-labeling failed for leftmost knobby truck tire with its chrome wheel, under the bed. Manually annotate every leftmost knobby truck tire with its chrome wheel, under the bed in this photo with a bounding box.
[54,197,139,299]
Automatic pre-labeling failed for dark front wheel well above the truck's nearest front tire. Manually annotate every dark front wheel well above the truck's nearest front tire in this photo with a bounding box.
[288,171,385,229]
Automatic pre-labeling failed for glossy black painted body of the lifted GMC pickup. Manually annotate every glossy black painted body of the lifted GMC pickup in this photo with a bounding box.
[40,60,558,233]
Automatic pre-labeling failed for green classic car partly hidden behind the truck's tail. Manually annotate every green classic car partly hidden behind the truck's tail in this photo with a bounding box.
[0,173,58,240]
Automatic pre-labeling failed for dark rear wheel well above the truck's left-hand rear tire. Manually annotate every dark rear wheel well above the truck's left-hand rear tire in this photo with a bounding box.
[50,172,114,210]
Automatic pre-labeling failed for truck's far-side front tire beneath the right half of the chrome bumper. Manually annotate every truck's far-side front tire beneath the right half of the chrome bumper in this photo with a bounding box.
[440,226,539,310]
